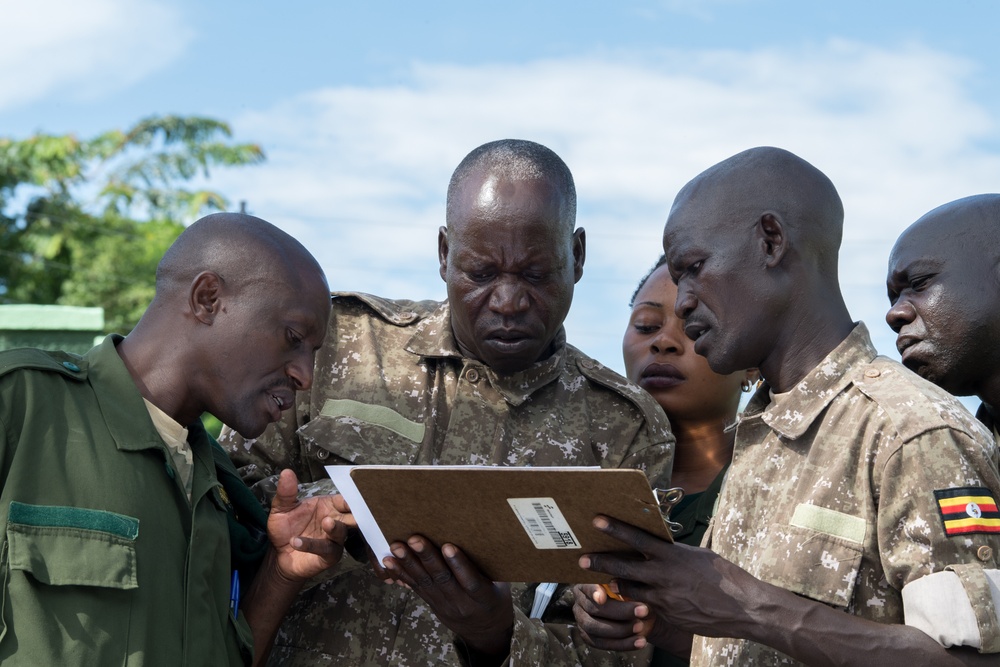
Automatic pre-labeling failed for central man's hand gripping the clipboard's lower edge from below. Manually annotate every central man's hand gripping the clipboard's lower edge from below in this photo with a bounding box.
[383,535,514,665]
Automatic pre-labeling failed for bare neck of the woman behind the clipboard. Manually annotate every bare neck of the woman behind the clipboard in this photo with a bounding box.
[670,418,735,494]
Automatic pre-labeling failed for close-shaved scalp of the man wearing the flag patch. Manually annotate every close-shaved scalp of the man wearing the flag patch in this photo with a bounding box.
[668,146,844,278]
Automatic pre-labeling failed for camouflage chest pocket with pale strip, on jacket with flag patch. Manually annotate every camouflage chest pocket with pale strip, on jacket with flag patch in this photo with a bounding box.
[757,504,867,609]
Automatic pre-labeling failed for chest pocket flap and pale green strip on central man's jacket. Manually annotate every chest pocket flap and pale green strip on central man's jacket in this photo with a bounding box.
[298,399,425,465]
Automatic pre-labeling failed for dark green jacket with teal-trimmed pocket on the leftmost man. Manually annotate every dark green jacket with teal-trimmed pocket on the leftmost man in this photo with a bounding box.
[0,336,252,667]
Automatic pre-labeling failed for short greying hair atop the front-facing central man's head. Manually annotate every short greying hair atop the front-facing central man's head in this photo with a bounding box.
[445,139,576,232]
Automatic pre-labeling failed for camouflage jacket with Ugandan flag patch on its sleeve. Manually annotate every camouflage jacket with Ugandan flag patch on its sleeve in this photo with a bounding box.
[691,324,1000,665]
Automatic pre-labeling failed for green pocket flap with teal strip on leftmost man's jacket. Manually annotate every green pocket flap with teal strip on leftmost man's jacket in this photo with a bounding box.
[7,502,139,590]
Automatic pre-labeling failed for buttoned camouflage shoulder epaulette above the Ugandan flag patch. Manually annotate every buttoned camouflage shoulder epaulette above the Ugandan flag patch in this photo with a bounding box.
[851,355,987,442]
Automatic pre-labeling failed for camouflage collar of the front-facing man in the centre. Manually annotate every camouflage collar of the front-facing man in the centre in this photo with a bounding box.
[406,301,566,406]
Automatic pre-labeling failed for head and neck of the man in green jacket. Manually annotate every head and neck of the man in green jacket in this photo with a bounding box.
[118,213,330,438]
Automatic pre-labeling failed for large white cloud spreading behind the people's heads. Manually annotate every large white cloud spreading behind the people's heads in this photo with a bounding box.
[216,41,1000,376]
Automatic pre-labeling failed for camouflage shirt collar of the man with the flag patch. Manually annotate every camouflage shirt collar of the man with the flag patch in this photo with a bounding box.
[744,322,878,440]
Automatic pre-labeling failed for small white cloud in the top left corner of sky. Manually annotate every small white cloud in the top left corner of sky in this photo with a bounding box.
[0,0,193,110]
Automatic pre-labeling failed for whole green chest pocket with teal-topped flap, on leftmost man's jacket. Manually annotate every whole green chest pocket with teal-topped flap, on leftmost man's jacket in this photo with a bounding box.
[0,502,139,665]
